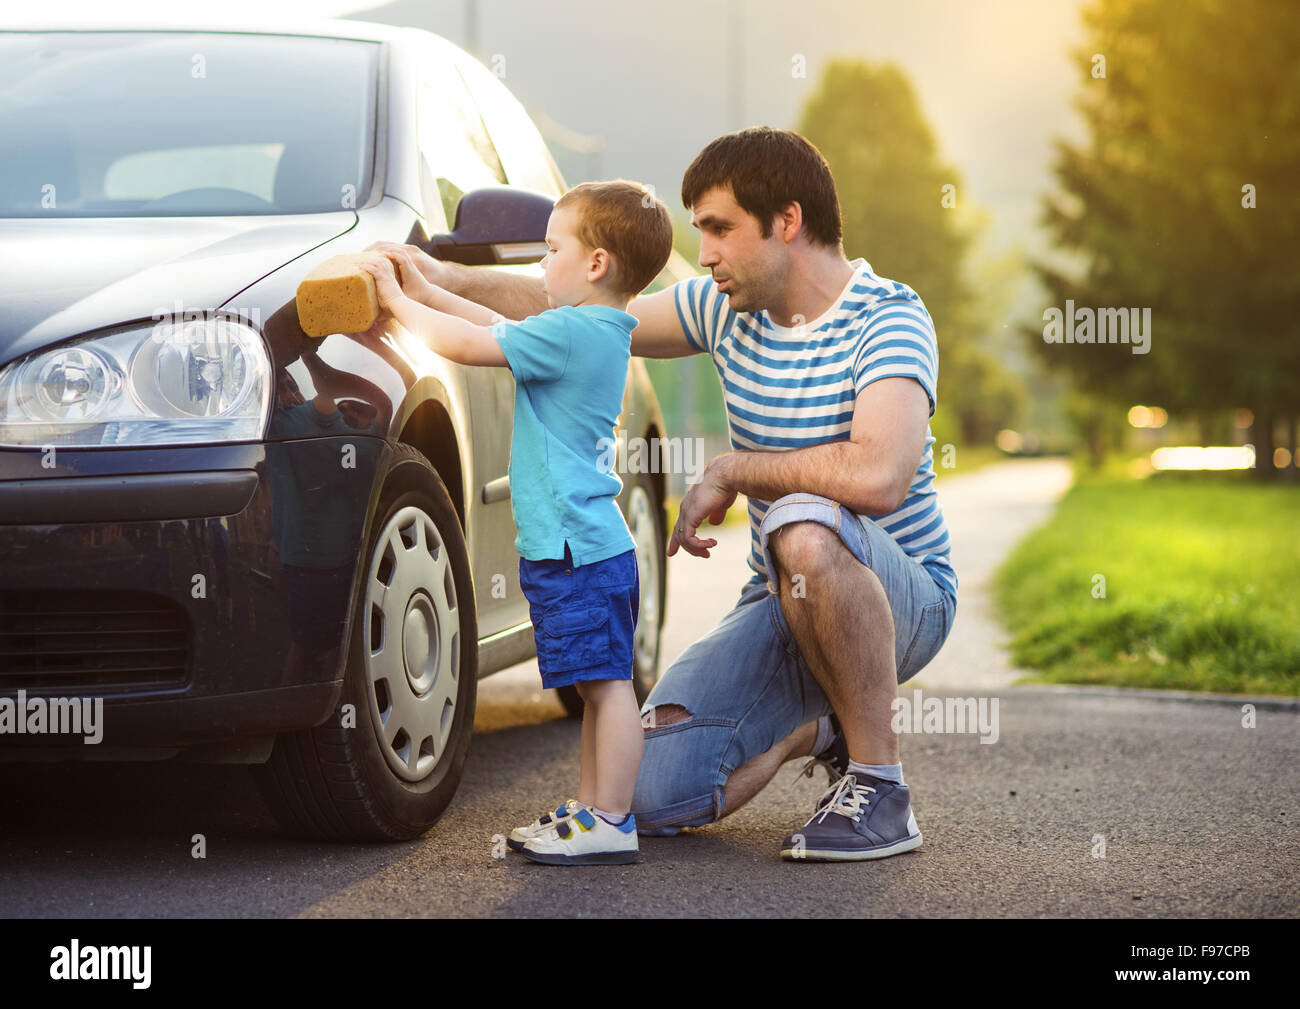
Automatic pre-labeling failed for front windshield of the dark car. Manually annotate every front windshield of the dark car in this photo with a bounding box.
[0,31,380,217]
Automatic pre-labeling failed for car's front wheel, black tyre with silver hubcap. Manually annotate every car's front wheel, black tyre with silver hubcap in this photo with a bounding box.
[255,443,478,841]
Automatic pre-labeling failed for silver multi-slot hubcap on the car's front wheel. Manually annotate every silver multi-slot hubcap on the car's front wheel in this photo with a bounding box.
[364,507,460,781]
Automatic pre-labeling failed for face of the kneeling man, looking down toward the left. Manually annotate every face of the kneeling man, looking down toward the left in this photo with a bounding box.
[690,187,787,312]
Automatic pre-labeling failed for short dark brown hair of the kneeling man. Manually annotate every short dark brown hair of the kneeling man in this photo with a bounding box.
[681,126,844,248]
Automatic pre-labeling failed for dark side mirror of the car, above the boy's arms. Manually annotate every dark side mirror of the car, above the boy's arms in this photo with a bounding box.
[425,186,555,267]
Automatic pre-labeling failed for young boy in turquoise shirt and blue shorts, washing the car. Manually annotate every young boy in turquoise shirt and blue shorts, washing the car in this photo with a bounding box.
[365,179,672,865]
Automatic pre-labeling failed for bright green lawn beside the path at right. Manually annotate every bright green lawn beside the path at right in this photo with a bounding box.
[996,468,1300,697]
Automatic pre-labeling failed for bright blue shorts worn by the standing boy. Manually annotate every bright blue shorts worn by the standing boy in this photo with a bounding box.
[519,544,641,690]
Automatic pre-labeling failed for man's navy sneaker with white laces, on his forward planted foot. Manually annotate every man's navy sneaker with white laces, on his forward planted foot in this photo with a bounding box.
[781,774,922,862]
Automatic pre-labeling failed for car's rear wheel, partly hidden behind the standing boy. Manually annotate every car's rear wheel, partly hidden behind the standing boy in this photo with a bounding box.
[556,473,668,718]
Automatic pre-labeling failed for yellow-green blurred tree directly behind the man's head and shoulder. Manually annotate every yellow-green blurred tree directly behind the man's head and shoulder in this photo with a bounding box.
[797,60,1024,445]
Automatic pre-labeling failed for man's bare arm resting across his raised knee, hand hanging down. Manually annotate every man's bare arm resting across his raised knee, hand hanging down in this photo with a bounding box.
[668,377,930,557]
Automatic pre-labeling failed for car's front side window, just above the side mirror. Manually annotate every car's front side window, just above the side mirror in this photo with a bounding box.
[416,60,506,226]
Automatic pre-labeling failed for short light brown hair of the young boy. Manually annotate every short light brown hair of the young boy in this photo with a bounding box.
[555,178,672,295]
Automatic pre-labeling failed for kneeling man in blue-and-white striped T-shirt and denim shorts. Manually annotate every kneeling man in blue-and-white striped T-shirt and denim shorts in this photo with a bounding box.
[371,127,957,861]
